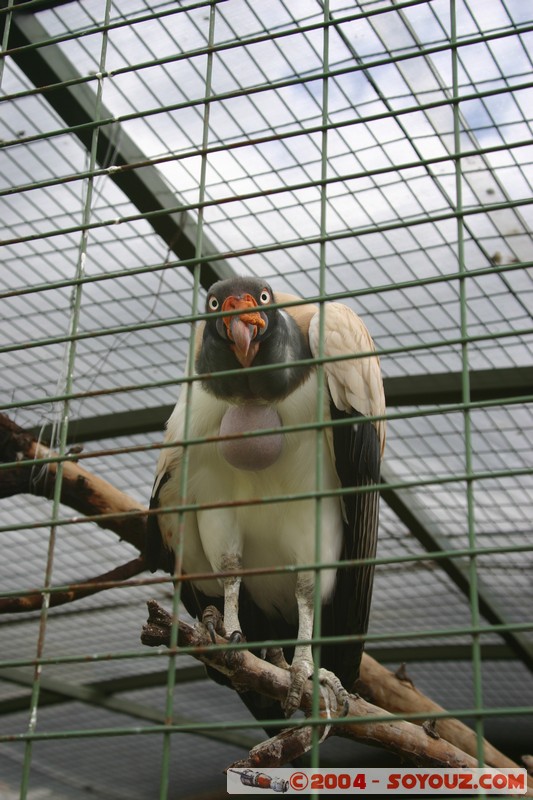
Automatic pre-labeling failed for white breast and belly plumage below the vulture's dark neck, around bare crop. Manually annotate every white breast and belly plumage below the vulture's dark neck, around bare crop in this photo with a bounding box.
[160,373,342,621]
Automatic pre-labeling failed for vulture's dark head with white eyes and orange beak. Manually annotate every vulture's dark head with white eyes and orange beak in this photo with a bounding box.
[206,278,276,367]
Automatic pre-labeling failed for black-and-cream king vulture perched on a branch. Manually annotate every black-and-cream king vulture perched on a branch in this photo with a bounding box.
[146,276,385,719]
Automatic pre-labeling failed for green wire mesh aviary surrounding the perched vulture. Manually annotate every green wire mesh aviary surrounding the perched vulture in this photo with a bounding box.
[0,0,533,800]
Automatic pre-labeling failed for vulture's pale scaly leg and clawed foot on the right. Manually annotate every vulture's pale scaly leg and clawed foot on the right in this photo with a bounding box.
[283,572,348,717]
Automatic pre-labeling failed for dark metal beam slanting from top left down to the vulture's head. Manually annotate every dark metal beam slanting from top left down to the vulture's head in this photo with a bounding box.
[5,13,235,289]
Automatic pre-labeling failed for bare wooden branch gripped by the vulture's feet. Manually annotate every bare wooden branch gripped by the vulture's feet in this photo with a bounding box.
[141,600,533,796]
